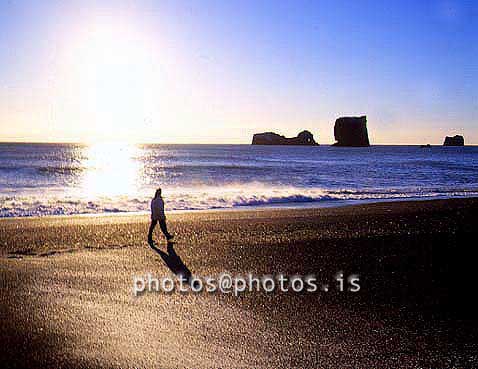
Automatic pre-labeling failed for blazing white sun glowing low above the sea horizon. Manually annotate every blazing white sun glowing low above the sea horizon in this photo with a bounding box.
[57,18,164,142]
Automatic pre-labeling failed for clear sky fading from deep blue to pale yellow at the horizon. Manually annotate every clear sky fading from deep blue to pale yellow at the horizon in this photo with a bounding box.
[0,0,478,144]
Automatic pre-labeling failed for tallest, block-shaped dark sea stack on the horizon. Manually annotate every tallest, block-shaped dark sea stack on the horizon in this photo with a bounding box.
[334,115,370,147]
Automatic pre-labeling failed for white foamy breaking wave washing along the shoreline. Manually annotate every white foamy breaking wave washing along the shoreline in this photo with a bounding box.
[0,185,478,217]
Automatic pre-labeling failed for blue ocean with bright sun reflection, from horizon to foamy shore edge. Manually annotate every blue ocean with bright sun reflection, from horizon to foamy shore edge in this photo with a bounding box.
[0,143,478,217]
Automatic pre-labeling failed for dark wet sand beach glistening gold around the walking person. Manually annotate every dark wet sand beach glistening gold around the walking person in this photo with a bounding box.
[0,198,478,368]
